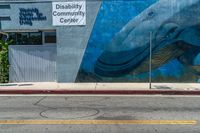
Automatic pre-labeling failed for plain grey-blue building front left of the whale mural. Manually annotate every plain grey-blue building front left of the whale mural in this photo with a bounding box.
[0,0,101,82]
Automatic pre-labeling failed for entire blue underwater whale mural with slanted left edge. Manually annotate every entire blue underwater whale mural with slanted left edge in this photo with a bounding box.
[76,0,200,82]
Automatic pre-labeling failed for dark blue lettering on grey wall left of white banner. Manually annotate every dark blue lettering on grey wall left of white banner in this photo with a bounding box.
[19,8,47,26]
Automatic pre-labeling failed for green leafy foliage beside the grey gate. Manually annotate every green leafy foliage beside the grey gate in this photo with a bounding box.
[0,40,12,83]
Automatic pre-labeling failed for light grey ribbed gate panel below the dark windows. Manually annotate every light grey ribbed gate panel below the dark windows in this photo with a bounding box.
[9,45,57,82]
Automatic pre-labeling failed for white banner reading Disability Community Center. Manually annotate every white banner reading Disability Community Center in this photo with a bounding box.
[52,0,86,26]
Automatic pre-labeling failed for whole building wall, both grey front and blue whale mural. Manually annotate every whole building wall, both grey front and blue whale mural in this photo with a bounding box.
[0,0,200,82]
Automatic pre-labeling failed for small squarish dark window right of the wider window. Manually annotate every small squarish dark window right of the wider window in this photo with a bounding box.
[44,31,56,44]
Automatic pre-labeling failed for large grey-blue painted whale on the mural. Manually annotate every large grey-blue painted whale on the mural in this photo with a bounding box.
[94,0,200,77]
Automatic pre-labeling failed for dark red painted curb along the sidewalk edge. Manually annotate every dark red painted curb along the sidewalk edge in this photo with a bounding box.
[0,89,200,95]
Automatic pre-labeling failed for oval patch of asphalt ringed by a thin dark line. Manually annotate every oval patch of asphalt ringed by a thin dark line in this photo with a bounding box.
[41,108,99,119]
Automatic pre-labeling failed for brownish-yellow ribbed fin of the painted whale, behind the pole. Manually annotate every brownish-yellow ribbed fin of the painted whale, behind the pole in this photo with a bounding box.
[131,44,185,74]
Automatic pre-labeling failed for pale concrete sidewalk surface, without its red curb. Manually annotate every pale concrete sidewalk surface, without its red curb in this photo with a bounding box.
[0,82,200,90]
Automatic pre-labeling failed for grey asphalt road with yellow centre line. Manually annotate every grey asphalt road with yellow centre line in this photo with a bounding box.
[0,96,200,133]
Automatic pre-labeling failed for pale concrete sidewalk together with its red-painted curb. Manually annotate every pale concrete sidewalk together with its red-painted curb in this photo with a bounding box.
[0,82,200,95]
